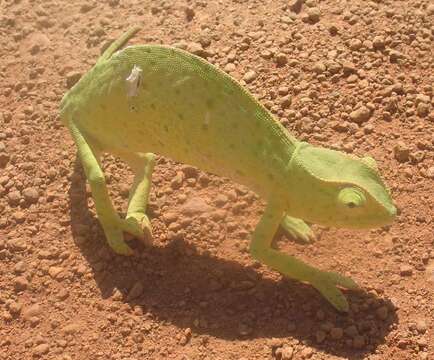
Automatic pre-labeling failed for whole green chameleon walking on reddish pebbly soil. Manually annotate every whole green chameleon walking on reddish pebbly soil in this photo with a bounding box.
[61,28,396,311]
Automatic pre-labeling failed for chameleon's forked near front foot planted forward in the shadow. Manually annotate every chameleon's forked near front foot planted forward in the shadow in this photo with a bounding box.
[309,271,358,312]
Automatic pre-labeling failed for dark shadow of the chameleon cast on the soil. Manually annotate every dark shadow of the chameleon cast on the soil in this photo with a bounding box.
[69,159,398,359]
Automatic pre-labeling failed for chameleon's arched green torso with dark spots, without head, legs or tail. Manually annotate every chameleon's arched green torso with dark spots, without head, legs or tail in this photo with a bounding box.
[63,46,291,197]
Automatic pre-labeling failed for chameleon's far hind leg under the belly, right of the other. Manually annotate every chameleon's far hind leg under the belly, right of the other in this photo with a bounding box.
[121,153,155,246]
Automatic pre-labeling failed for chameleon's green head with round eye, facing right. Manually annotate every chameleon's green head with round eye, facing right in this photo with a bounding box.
[288,143,396,228]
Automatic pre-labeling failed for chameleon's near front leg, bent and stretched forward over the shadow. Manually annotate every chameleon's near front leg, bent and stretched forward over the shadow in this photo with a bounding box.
[250,200,357,311]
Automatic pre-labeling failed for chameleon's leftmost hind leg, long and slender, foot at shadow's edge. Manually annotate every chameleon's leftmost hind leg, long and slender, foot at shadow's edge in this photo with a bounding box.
[68,122,141,255]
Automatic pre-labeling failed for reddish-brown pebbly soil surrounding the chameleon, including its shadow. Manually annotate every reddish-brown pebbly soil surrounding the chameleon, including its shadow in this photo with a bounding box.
[0,0,434,360]
